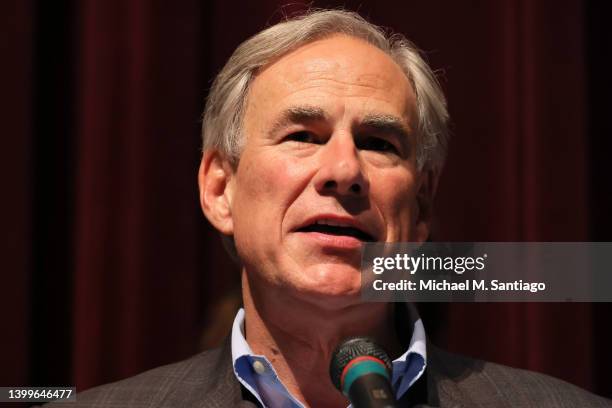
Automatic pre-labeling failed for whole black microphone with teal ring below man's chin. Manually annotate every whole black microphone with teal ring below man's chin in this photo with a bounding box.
[329,337,398,408]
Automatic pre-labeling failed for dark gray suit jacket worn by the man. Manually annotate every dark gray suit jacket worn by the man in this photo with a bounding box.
[49,339,612,408]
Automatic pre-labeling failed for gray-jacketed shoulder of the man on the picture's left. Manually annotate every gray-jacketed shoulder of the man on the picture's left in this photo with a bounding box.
[47,347,240,408]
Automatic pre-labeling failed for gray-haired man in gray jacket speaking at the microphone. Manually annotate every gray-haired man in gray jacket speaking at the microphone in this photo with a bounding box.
[47,7,610,407]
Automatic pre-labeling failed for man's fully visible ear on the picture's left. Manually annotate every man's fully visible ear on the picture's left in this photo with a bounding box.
[198,150,234,235]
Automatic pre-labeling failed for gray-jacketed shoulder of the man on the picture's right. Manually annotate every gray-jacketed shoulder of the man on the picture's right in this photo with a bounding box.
[428,347,612,408]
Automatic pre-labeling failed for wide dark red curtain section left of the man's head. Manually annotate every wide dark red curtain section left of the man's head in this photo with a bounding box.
[73,1,202,387]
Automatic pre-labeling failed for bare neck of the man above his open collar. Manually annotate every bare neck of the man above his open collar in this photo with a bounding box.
[242,271,402,408]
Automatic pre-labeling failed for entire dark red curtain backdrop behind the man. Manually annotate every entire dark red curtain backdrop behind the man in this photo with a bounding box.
[0,0,612,397]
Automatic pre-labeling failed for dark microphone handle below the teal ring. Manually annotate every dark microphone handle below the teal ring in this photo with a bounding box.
[348,373,398,408]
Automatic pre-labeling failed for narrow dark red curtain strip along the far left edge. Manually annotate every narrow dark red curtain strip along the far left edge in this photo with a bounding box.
[0,0,33,386]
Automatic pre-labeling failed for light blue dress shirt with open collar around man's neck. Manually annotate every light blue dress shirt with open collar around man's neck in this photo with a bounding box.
[232,305,427,408]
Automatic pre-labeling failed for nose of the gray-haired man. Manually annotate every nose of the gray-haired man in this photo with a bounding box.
[314,135,369,197]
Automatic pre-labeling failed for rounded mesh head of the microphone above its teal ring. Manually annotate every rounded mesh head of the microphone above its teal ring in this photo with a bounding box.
[329,337,392,394]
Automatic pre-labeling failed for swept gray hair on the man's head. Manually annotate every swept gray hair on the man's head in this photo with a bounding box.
[202,10,449,169]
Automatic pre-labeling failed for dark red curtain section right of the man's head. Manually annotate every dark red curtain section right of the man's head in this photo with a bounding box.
[428,1,596,388]
